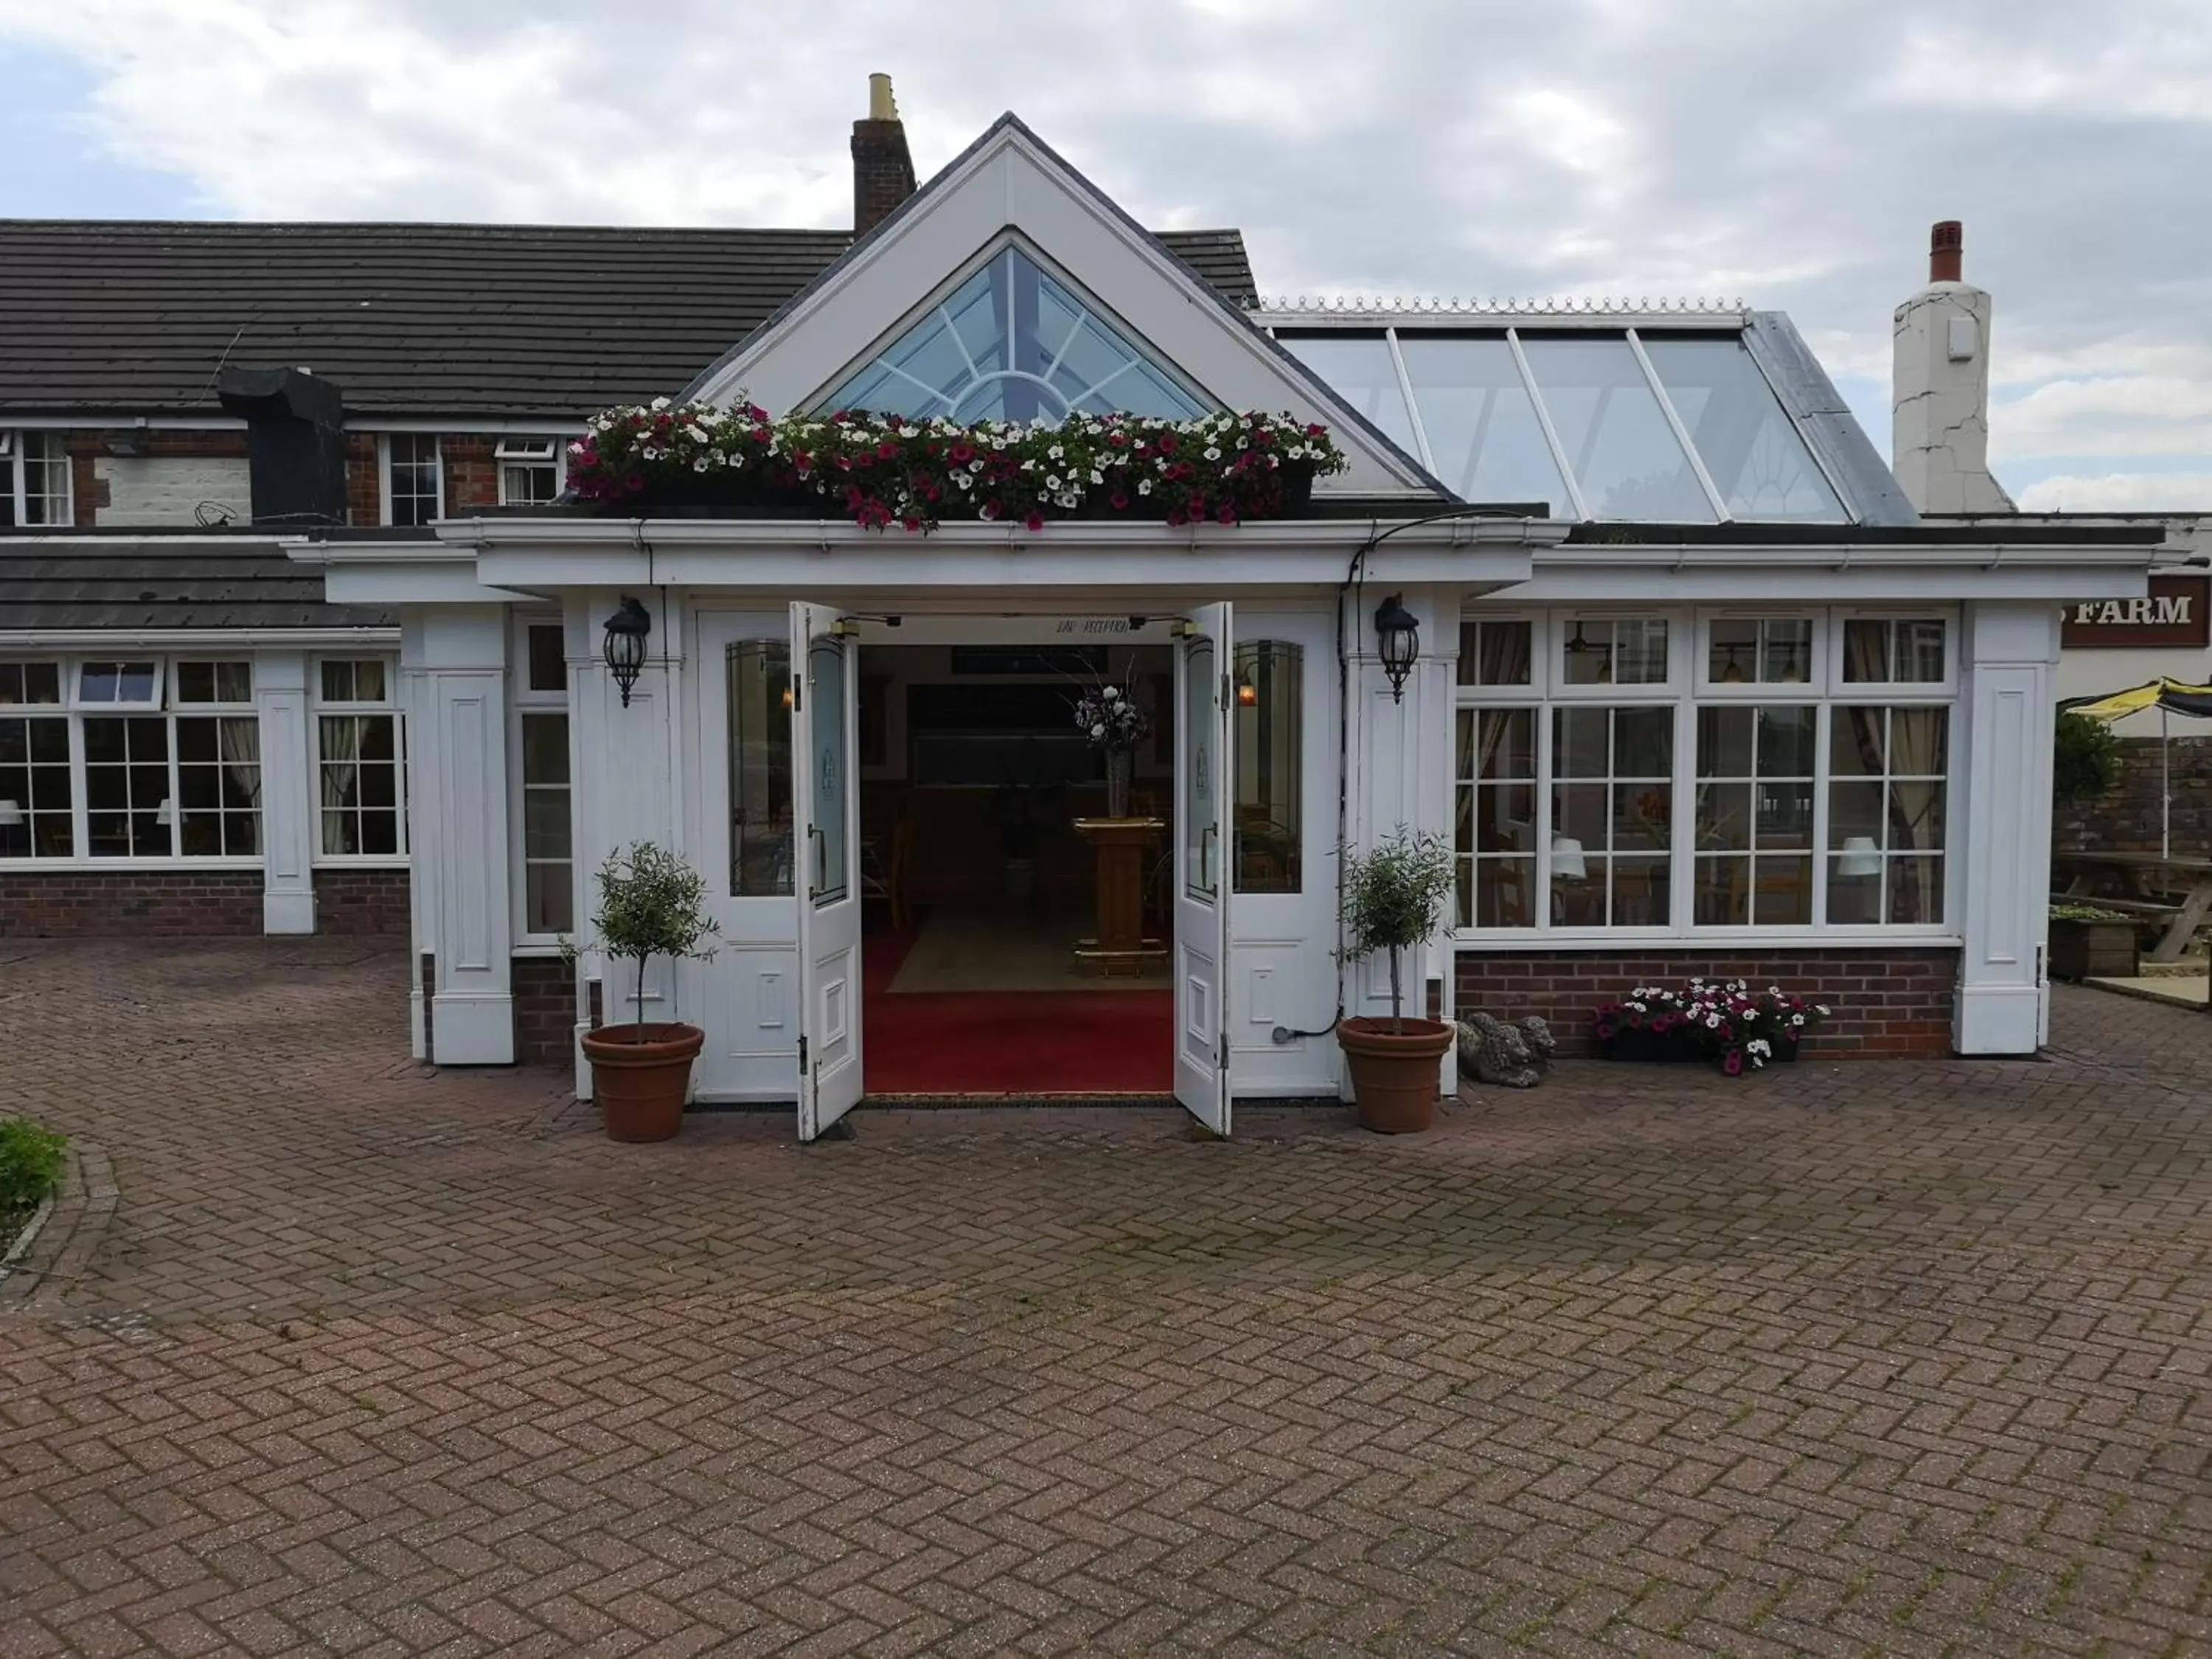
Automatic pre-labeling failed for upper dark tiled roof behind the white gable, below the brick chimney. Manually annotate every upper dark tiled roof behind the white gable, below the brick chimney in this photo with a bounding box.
[0,219,1254,418]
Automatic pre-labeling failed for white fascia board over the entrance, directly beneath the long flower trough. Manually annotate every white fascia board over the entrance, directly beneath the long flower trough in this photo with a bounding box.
[449,518,1571,595]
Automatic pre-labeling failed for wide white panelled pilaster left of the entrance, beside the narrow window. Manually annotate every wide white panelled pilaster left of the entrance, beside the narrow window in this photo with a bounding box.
[409,606,515,1066]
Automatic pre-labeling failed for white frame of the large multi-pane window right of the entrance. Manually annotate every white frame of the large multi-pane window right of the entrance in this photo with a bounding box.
[1447,604,1964,949]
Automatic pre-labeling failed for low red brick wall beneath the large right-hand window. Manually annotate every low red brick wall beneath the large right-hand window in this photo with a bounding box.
[1458,945,1958,1057]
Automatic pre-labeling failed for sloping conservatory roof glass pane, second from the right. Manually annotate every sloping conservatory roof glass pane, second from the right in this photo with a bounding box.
[1522,334,1717,524]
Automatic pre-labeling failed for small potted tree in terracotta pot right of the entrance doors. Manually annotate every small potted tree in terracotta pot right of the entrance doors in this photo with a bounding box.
[1336,830,1455,1135]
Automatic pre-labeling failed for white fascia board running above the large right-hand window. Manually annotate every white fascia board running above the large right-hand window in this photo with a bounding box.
[1513,544,2150,604]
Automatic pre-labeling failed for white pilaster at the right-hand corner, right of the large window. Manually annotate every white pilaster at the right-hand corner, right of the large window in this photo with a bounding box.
[1951,604,2059,1055]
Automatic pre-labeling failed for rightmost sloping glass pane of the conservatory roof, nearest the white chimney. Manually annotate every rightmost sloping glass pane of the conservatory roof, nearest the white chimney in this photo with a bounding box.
[1644,334,1845,524]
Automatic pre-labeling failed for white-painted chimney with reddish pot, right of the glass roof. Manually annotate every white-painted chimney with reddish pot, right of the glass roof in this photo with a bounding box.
[1889,219,2015,513]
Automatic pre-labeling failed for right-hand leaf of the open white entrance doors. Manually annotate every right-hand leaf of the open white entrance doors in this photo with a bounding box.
[1175,604,1237,1135]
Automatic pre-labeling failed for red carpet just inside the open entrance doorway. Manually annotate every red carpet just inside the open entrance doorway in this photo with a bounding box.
[860,933,1175,1095]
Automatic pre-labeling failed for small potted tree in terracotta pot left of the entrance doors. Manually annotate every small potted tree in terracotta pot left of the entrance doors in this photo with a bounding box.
[562,841,714,1141]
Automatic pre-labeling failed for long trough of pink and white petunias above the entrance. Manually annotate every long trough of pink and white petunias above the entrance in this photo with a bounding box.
[568,398,1347,531]
